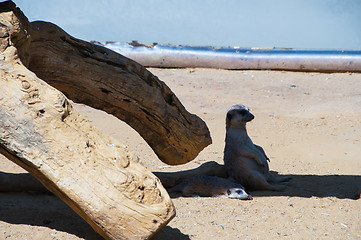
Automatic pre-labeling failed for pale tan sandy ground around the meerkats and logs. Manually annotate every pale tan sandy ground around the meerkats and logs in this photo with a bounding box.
[0,68,361,240]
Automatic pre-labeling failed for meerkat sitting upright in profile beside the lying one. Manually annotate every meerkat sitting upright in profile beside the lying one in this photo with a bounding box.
[224,104,290,191]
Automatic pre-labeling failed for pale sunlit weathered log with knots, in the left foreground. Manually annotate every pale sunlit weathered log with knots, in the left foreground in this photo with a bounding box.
[0,2,175,239]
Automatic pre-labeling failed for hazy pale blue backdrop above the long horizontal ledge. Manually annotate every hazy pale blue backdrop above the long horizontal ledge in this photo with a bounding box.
[14,0,361,49]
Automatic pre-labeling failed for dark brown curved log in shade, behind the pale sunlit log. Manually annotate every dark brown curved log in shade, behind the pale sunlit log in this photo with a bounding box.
[28,22,211,165]
